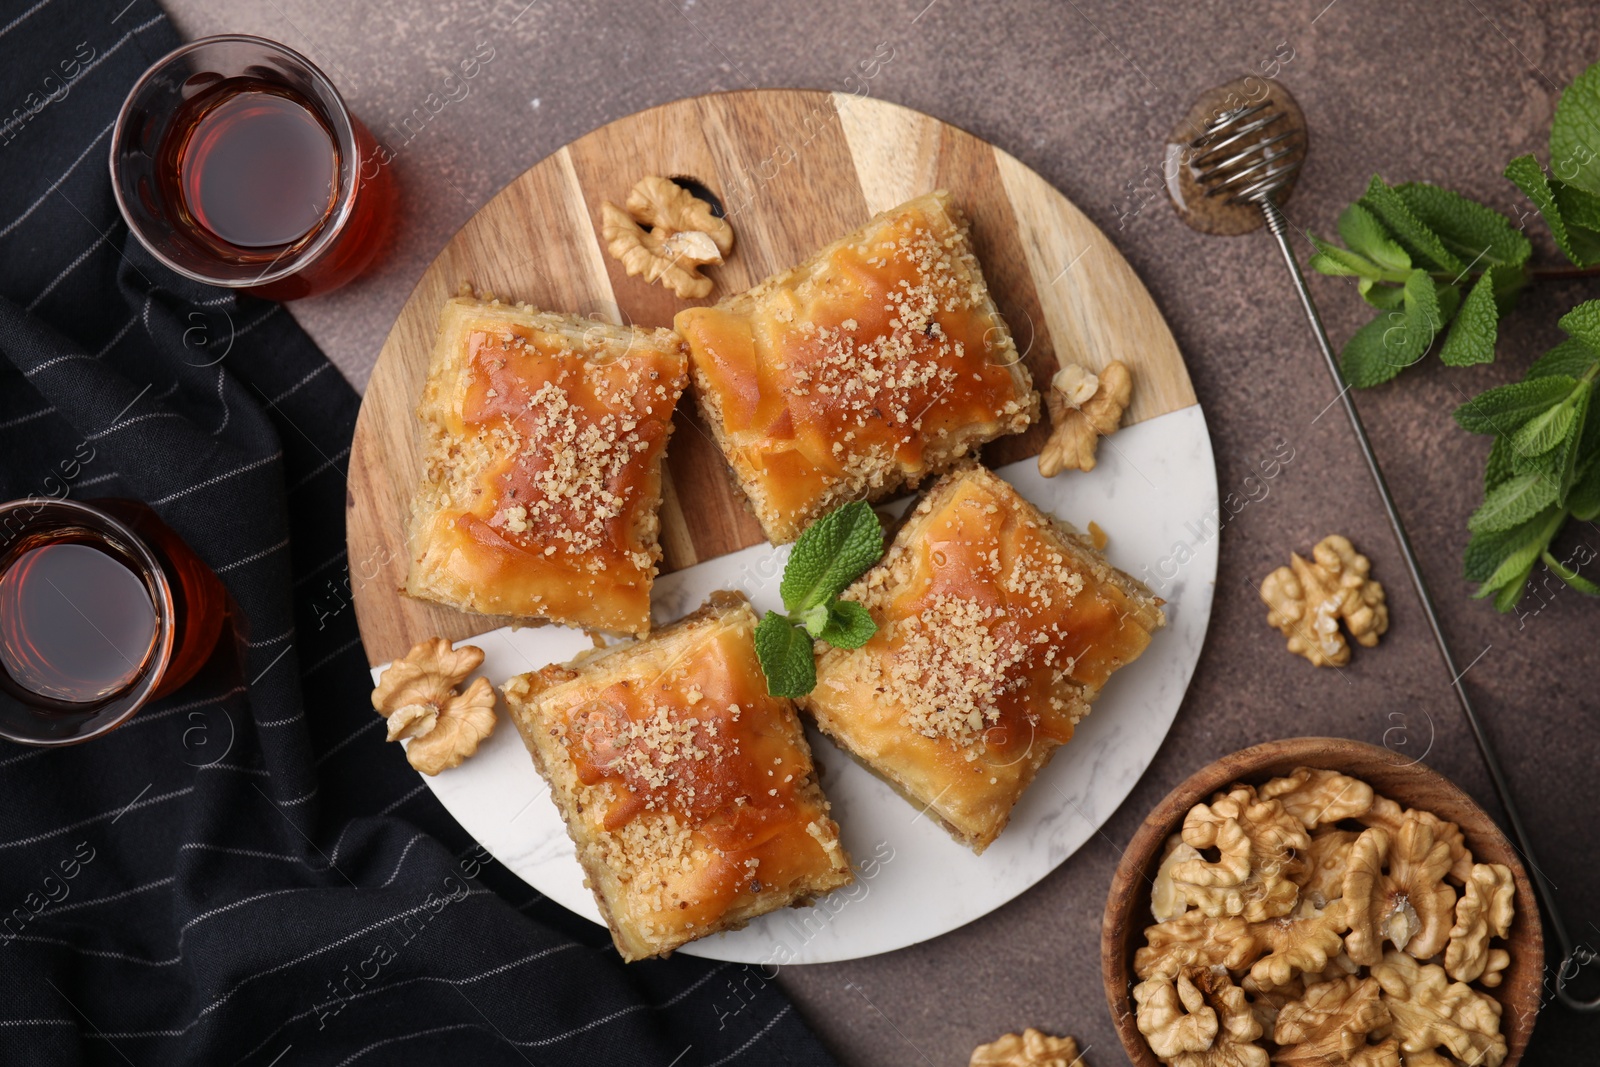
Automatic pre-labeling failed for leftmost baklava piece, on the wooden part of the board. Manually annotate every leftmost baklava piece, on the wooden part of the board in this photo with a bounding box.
[405,298,688,633]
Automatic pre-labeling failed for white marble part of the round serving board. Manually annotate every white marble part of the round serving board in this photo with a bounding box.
[373,405,1219,963]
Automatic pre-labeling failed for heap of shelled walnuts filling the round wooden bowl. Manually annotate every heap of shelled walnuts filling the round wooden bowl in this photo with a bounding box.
[1133,768,1515,1067]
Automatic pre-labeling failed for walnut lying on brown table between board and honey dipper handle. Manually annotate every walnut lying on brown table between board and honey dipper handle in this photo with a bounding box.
[1261,534,1389,667]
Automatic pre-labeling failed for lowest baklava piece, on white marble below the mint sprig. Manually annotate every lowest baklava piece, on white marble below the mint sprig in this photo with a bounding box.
[506,593,853,960]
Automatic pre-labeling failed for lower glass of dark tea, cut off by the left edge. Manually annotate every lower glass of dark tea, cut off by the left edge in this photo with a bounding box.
[0,498,227,745]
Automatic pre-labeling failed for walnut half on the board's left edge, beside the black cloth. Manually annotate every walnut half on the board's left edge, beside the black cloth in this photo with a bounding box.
[373,637,494,774]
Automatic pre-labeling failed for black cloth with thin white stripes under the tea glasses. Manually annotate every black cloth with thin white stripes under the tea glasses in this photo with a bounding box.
[0,0,832,1067]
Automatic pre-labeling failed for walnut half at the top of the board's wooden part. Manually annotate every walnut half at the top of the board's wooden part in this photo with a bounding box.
[600,176,733,299]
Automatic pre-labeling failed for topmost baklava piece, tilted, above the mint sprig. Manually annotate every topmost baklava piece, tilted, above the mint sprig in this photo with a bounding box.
[675,190,1038,544]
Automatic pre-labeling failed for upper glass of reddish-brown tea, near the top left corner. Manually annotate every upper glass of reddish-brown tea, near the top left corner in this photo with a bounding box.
[110,34,395,301]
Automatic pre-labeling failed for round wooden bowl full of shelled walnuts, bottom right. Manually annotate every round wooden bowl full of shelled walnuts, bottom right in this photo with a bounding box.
[1101,737,1544,1067]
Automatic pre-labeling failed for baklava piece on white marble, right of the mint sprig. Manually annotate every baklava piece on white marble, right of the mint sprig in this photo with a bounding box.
[800,462,1166,853]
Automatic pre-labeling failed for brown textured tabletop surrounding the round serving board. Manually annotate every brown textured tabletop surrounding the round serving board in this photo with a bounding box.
[168,0,1600,1067]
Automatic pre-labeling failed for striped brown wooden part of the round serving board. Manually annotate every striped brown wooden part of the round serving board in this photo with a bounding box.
[346,90,1195,665]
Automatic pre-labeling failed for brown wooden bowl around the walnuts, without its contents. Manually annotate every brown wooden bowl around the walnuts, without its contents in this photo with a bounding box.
[1101,737,1544,1067]
